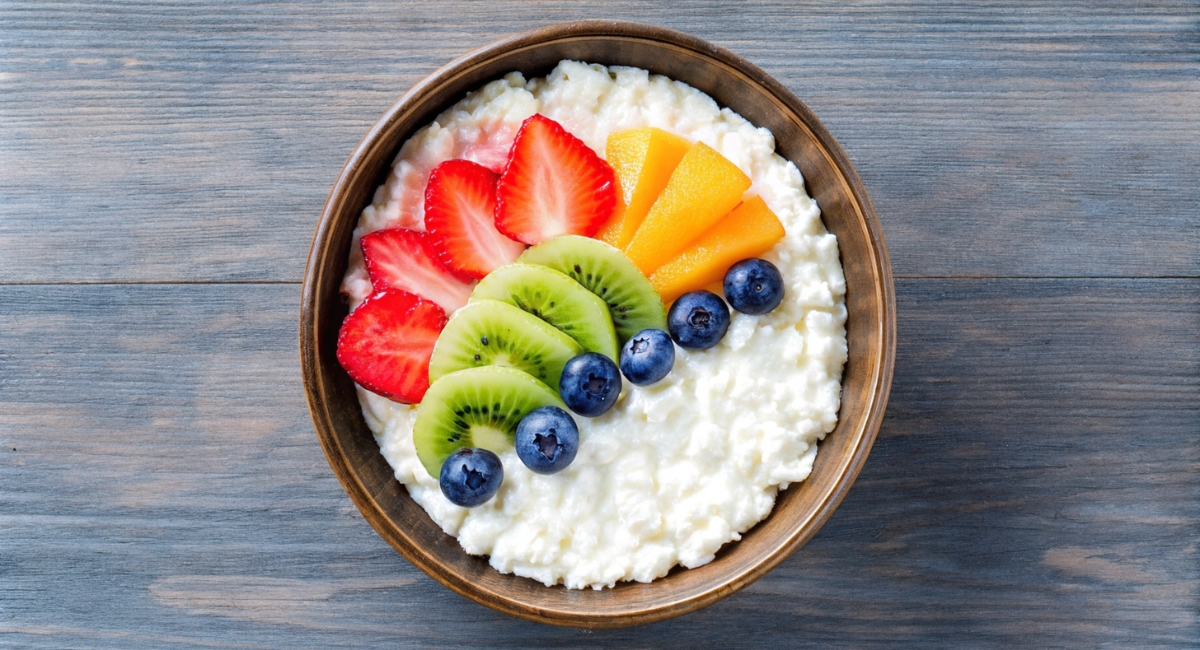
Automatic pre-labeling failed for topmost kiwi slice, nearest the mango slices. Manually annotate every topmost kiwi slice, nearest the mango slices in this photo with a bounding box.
[517,235,667,344]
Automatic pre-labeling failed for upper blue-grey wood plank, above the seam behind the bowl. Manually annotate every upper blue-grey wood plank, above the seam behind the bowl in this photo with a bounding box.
[0,0,1200,282]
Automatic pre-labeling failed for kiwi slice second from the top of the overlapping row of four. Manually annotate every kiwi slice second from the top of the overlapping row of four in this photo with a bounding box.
[469,264,620,366]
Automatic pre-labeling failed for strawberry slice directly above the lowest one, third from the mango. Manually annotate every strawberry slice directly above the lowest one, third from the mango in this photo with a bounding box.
[361,228,474,313]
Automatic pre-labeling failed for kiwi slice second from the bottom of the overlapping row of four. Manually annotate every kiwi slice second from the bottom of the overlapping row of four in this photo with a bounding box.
[430,300,583,389]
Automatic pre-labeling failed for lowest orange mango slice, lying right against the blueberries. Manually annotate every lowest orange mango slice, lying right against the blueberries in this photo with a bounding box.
[650,197,784,305]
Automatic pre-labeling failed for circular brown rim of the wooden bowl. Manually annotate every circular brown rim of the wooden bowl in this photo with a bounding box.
[299,20,896,628]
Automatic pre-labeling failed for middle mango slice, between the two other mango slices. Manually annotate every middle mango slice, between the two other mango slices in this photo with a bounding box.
[625,143,750,276]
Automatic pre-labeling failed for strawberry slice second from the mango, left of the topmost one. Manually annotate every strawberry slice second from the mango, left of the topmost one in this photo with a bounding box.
[425,161,524,278]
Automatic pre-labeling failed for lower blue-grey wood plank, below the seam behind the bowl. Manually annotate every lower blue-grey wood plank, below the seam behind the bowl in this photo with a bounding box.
[0,279,1200,648]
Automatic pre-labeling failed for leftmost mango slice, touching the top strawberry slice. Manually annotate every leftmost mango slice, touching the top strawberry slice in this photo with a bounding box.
[596,126,691,248]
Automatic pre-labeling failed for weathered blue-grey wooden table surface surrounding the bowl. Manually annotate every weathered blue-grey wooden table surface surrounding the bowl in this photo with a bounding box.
[0,0,1200,648]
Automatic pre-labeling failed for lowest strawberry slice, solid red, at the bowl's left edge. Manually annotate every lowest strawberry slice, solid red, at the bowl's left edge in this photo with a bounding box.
[337,289,446,404]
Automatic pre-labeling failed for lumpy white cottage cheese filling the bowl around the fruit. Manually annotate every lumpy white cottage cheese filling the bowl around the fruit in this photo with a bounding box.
[343,61,846,589]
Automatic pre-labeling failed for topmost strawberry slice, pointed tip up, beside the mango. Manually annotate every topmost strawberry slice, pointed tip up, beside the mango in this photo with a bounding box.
[496,115,617,243]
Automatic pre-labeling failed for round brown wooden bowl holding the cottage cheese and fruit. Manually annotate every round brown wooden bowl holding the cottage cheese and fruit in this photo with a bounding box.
[300,20,895,627]
